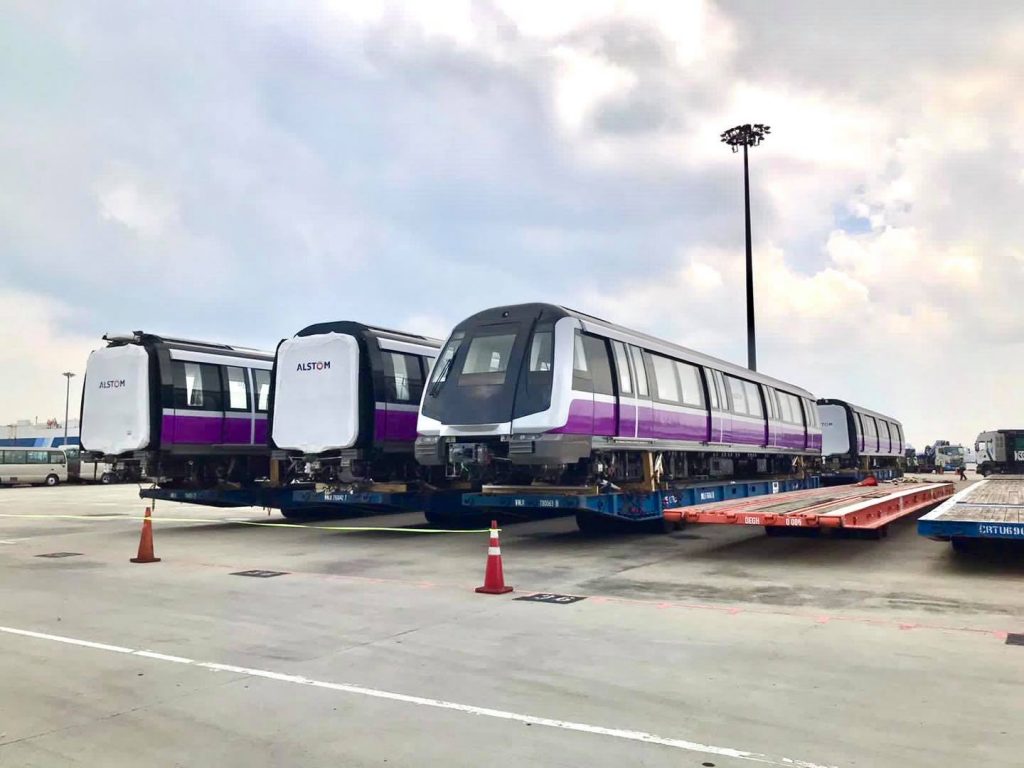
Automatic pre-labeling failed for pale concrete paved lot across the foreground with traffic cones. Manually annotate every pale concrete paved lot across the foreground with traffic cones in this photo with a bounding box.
[0,486,1024,768]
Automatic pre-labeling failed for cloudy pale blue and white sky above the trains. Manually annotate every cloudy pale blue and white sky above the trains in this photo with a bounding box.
[0,0,1024,446]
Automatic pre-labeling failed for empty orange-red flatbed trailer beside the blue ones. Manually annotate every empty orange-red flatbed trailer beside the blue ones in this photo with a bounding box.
[665,482,955,536]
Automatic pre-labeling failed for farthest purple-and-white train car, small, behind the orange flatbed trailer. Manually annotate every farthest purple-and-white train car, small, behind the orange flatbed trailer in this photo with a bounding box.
[817,398,906,470]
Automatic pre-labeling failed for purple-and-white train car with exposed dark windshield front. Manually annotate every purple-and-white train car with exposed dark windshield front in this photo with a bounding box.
[416,304,821,484]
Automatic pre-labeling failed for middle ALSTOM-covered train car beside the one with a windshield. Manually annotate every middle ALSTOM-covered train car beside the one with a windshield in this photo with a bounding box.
[270,322,441,483]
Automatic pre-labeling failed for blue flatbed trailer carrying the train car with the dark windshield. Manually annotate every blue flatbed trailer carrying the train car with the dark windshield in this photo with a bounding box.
[462,475,820,529]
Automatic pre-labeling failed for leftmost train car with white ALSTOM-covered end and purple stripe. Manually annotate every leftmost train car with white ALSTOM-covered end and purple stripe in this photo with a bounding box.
[81,331,273,487]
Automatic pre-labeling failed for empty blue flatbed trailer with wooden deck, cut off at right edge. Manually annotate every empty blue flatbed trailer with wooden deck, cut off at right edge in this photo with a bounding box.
[918,475,1024,550]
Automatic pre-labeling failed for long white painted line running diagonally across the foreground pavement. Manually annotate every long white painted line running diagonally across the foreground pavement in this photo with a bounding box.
[0,627,836,768]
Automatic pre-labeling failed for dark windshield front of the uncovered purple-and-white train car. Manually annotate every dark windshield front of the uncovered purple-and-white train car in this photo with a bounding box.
[423,314,554,425]
